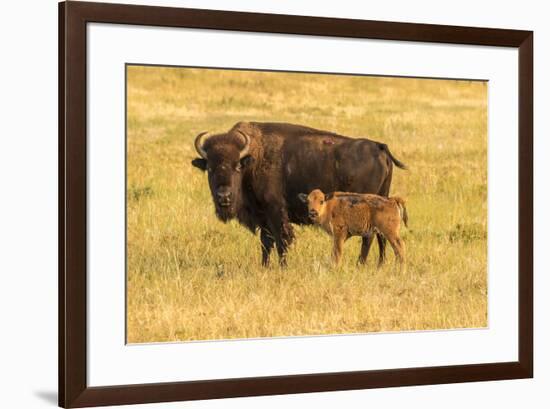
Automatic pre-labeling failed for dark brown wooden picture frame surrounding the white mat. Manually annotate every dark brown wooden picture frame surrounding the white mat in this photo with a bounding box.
[59,2,533,407]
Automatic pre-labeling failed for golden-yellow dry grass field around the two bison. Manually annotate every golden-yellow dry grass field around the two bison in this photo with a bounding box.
[127,66,487,343]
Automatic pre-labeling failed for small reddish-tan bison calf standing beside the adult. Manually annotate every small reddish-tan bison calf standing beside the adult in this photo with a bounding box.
[298,189,408,271]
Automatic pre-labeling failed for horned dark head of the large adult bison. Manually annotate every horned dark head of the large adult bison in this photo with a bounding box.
[191,130,252,222]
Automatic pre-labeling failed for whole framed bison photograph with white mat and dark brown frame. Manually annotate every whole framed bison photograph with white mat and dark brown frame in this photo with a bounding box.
[59,1,533,407]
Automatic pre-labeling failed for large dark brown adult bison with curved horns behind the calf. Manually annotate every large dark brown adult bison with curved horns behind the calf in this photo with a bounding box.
[192,122,405,265]
